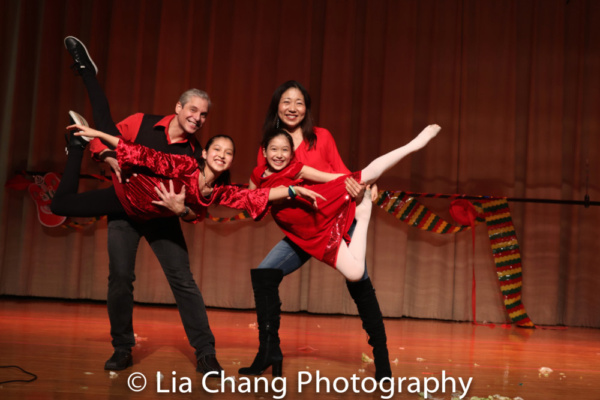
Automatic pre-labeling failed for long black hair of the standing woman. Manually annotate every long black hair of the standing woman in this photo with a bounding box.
[262,81,317,150]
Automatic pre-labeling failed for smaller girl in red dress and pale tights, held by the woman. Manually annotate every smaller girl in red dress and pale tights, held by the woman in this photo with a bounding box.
[249,125,441,281]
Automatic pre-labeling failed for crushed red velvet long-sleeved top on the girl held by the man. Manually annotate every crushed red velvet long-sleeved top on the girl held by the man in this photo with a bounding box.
[115,140,269,221]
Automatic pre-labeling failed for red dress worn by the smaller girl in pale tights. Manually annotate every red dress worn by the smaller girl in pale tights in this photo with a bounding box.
[250,161,360,268]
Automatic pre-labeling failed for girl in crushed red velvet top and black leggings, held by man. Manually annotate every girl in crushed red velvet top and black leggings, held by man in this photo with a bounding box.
[51,124,321,221]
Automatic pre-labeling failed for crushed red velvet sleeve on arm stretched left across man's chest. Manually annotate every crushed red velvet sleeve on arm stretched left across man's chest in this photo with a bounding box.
[117,140,198,178]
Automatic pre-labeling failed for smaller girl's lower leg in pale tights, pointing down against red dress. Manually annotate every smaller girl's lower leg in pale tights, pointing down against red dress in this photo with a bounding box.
[335,190,373,282]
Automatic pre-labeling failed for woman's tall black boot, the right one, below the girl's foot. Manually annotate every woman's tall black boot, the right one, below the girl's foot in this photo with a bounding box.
[346,278,392,381]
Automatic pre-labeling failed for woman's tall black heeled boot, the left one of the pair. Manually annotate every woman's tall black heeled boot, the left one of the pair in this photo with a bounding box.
[238,269,283,376]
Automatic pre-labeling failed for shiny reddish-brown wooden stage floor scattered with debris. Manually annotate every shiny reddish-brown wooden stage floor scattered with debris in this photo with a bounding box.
[0,298,600,400]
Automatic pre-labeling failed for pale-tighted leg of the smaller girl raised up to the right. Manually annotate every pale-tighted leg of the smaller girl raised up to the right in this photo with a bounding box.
[361,125,442,185]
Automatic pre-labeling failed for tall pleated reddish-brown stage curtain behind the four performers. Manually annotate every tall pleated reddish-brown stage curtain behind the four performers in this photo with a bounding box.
[0,0,600,328]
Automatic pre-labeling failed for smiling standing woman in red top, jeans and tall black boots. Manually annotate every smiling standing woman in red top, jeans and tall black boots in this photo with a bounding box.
[239,81,392,380]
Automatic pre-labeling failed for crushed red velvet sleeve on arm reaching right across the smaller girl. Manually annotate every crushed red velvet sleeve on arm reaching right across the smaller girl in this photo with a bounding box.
[216,186,271,221]
